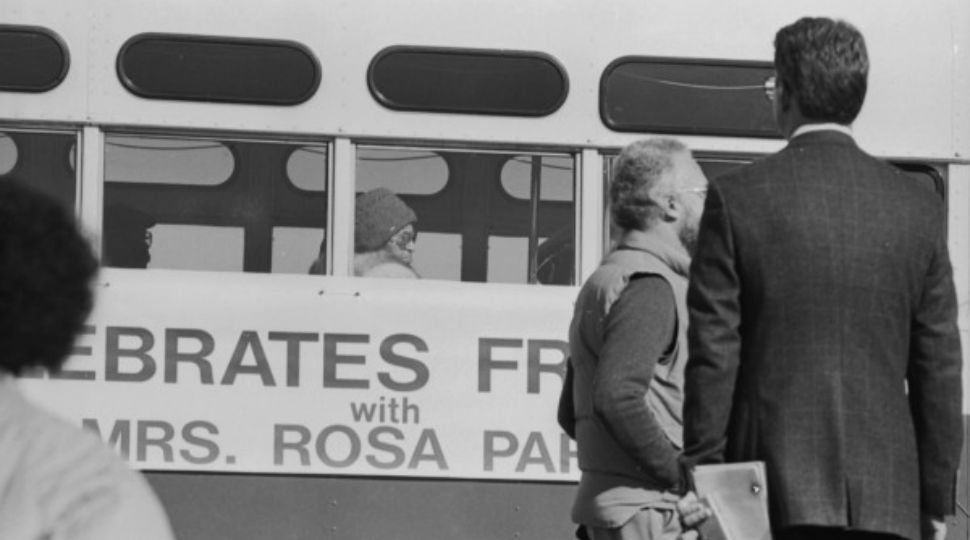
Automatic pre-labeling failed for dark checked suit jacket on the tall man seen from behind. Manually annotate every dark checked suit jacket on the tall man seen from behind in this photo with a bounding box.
[683,131,962,538]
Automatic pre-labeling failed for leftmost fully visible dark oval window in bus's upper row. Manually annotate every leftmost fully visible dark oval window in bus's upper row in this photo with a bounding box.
[117,34,320,105]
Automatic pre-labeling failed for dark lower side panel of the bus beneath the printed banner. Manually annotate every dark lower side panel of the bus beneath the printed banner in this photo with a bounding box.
[146,472,576,540]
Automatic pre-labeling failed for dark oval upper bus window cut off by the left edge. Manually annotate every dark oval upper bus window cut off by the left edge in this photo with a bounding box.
[0,24,69,92]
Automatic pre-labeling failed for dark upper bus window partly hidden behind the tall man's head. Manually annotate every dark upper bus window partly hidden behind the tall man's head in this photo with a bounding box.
[600,56,781,138]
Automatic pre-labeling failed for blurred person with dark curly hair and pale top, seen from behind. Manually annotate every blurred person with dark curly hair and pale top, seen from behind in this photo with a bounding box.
[0,182,173,540]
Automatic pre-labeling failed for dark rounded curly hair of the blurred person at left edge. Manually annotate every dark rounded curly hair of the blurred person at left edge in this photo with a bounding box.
[0,181,98,375]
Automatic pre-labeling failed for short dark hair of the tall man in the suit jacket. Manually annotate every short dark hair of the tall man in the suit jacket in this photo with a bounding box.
[775,17,869,124]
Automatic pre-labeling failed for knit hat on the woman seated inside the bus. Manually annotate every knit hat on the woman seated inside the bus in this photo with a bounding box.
[354,188,418,253]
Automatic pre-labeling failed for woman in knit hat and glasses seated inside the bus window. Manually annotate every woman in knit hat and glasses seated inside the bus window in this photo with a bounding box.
[354,188,418,277]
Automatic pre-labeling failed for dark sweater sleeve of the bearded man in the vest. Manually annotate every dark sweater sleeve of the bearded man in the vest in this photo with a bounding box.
[593,275,680,486]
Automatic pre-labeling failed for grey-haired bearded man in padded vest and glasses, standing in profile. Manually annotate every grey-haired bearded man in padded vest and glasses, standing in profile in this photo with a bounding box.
[559,138,707,540]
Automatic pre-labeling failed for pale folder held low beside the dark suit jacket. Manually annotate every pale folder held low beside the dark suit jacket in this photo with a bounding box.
[691,461,771,540]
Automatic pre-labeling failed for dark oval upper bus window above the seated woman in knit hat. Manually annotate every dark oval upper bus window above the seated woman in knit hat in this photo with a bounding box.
[367,47,569,116]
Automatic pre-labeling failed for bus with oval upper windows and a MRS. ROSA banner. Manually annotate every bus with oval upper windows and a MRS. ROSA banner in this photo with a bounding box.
[0,0,970,540]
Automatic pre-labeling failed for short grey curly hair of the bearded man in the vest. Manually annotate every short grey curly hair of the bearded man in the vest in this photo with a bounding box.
[610,137,689,231]
